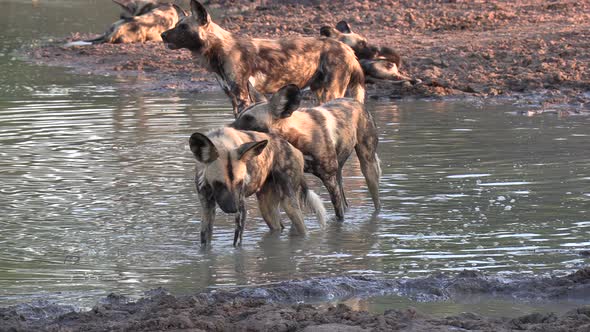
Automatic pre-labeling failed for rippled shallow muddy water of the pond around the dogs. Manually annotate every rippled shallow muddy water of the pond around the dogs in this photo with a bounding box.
[0,0,590,314]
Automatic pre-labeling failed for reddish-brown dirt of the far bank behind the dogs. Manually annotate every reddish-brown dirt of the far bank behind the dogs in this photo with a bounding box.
[29,0,590,111]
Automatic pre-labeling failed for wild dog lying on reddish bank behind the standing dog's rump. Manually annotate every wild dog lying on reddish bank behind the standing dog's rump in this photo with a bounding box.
[320,21,412,81]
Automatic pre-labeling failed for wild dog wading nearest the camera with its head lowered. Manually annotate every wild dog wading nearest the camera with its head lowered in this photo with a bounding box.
[189,127,326,246]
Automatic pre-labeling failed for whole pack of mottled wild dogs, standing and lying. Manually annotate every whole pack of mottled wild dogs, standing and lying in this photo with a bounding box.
[72,0,410,246]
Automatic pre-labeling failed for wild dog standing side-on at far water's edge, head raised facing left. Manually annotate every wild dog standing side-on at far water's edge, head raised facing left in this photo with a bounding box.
[162,0,365,116]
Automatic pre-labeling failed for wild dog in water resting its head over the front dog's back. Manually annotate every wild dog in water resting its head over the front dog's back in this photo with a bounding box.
[232,85,381,221]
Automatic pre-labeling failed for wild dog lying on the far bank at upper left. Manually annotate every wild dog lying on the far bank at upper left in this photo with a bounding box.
[66,0,186,46]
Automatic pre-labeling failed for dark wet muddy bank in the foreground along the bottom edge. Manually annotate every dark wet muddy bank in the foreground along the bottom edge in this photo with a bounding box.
[0,268,590,331]
